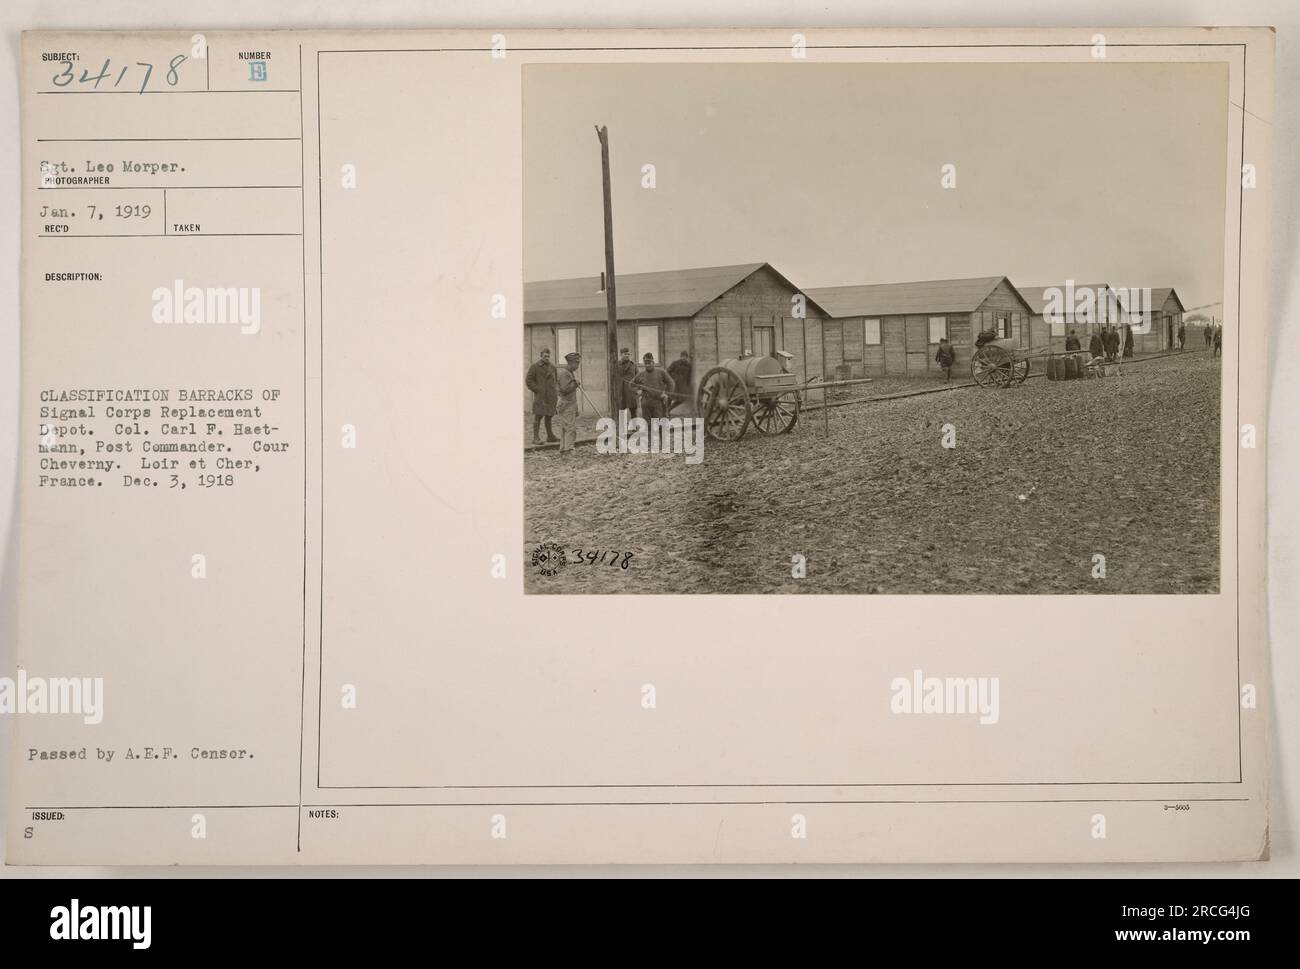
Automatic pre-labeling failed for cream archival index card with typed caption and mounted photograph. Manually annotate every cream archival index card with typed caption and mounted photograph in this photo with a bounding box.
[0,29,1273,864]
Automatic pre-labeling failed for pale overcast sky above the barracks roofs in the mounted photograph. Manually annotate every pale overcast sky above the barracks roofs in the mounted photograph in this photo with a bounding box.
[524,62,1227,311]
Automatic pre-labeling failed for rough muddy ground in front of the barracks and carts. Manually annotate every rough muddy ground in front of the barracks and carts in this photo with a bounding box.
[524,352,1219,594]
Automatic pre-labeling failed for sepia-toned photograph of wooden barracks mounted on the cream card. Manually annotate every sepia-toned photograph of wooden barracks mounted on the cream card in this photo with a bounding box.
[521,62,1227,594]
